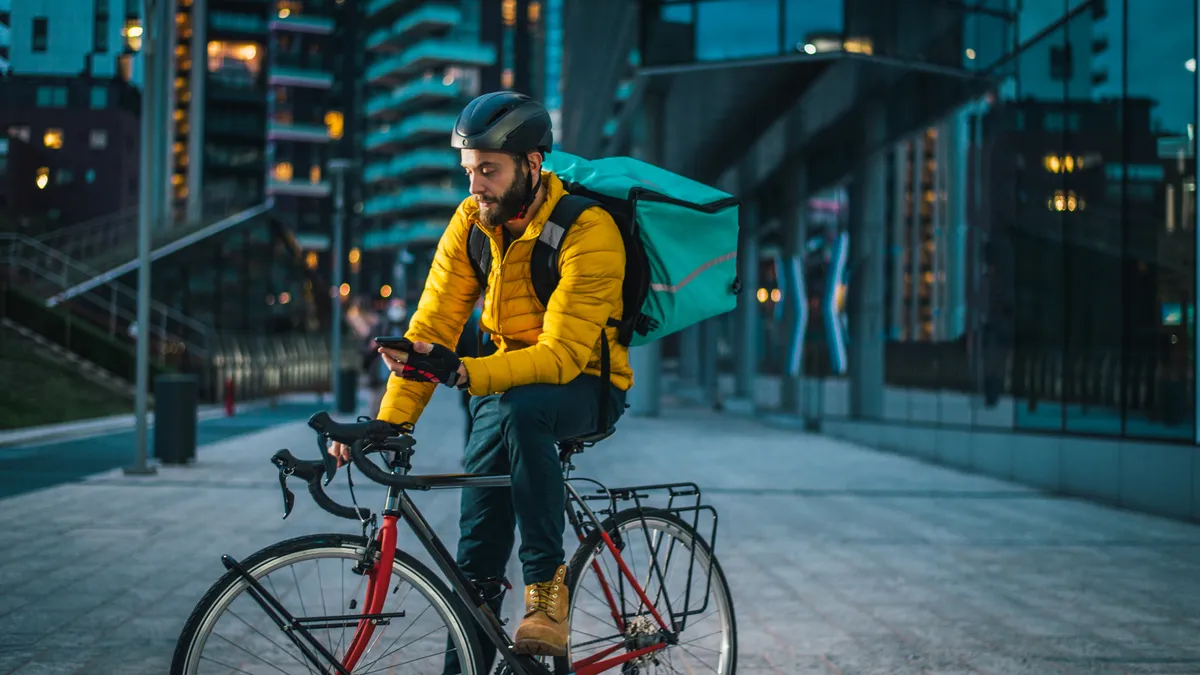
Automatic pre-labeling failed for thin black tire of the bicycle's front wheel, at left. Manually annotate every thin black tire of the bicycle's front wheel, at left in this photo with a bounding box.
[170,533,486,675]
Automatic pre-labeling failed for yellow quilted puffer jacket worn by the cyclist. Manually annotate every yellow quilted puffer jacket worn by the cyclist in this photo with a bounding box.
[379,172,634,424]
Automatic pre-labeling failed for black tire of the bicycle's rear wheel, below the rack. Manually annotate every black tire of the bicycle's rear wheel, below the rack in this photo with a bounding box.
[554,508,738,675]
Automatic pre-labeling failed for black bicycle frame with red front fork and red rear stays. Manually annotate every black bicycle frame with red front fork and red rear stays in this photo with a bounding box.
[222,458,690,675]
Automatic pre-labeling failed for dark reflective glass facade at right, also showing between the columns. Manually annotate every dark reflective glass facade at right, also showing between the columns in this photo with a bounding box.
[760,0,1196,443]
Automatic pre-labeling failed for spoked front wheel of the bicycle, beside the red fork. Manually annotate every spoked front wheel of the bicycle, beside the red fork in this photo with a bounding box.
[170,534,484,675]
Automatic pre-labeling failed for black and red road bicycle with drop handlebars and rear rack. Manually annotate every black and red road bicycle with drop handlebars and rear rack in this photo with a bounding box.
[170,412,737,675]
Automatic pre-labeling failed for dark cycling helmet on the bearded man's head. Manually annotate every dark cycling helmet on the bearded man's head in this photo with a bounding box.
[450,91,554,154]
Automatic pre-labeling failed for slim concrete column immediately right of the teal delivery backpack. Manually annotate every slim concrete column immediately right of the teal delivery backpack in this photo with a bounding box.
[728,192,762,412]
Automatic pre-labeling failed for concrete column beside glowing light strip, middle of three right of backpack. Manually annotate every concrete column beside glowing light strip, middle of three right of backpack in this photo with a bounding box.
[779,165,809,413]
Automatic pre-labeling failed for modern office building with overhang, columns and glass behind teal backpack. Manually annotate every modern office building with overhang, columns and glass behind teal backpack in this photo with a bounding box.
[563,0,1200,519]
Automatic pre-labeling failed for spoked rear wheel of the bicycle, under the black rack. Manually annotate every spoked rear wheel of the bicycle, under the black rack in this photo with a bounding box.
[554,509,738,675]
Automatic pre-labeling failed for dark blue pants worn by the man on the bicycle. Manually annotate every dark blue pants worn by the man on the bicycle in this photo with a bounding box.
[445,375,625,673]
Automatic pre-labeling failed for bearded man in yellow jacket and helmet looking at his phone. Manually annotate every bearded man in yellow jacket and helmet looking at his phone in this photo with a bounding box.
[330,91,632,671]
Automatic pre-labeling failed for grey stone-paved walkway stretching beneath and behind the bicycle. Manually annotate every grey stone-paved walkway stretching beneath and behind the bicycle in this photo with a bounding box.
[0,392,1200,675]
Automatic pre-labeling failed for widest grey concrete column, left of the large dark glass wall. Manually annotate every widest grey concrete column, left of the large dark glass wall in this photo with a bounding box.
[847,107,888,419]
